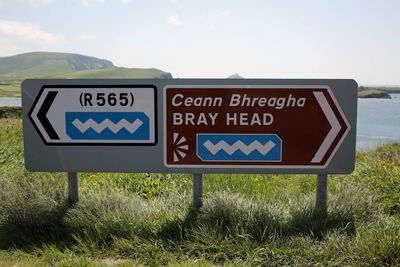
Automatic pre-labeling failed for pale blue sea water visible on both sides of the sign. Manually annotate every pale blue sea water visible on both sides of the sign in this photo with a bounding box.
[0,94,400,151]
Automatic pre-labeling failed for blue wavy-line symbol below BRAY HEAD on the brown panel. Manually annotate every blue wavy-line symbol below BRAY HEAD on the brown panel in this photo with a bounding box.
[197,134,282,162]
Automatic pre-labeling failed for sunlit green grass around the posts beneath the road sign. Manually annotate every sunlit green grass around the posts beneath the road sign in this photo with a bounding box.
[0,115,400,266]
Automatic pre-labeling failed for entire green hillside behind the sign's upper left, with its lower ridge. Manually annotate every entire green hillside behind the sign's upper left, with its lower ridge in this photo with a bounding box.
[0,52,172,97]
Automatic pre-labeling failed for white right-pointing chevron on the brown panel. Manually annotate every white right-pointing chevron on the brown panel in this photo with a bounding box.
[311,92,342,163]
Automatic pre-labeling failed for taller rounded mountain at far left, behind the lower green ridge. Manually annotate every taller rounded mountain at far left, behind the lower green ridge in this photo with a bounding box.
[0,52,115,78]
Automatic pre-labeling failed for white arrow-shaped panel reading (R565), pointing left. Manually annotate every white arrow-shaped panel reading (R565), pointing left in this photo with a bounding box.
[29,85,156,145]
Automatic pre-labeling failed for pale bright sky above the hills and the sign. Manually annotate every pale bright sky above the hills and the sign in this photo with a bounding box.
[0,0,400,85]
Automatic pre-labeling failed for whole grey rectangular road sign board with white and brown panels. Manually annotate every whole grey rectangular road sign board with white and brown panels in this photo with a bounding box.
[22,79,357,174]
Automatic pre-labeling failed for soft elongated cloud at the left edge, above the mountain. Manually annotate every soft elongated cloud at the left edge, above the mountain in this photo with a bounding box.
[0,19,65,44]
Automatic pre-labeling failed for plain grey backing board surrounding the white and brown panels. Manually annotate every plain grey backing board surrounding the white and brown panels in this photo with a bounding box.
[22,79,358,174]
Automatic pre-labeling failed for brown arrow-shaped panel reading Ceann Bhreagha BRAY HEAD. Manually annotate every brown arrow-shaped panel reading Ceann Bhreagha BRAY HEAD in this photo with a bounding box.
[163,85,350,168]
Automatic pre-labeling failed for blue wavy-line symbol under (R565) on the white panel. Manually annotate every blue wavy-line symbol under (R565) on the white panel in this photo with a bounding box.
[65,112,150,140]
